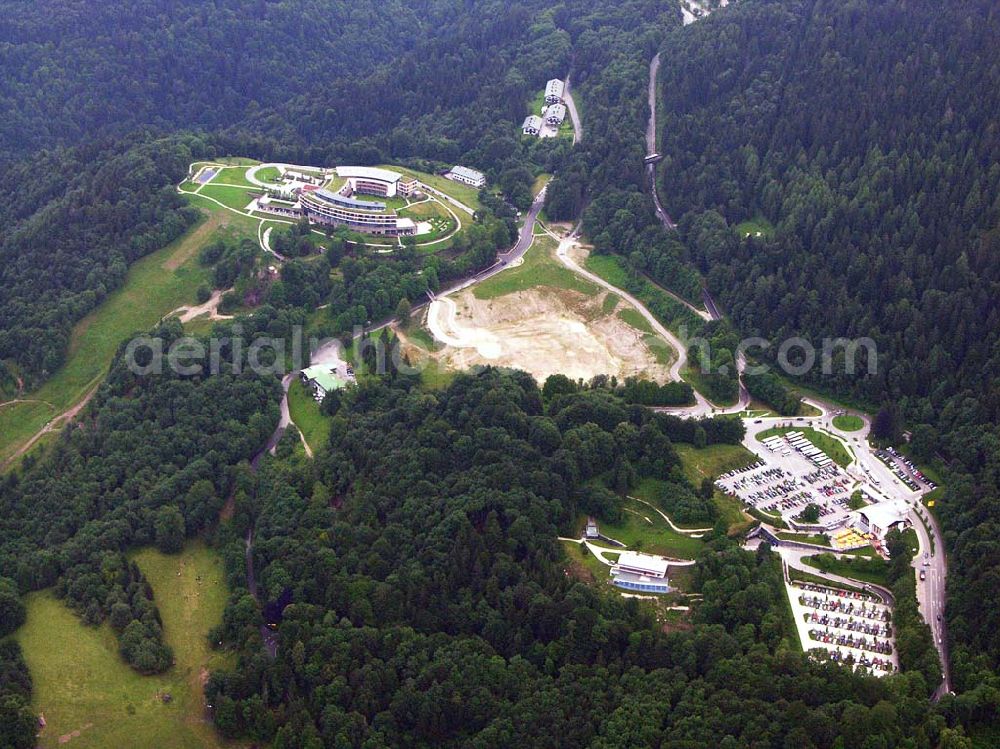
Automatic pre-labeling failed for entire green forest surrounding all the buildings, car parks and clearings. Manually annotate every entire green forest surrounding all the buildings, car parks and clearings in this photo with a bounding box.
[0,0,1000,749]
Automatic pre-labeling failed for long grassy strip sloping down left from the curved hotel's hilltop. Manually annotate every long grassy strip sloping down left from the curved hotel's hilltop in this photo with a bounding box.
[0,210,234,462]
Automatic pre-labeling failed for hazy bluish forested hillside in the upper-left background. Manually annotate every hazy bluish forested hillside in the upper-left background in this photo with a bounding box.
[0,0,498,162]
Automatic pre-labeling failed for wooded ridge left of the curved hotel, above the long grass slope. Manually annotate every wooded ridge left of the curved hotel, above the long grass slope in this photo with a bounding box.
[0,137,199,385]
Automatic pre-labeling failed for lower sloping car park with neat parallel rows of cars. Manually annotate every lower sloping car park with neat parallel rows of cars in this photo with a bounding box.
[785,582,899,676]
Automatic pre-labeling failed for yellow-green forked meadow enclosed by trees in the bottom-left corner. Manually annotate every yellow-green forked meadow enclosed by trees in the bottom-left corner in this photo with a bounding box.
[15,543,232,749]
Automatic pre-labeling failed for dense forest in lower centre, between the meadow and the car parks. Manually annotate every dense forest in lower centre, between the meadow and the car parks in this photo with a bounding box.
[199,370,945,747]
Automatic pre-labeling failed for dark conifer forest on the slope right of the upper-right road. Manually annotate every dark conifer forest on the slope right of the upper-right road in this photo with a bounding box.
[648,0,1000,689]
